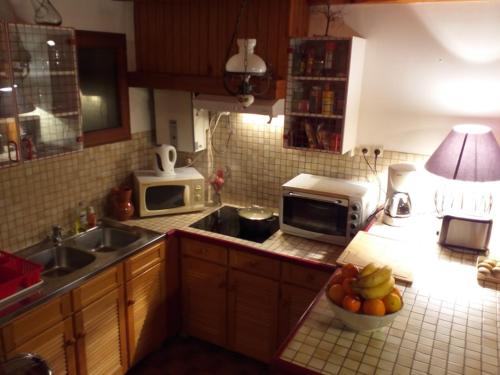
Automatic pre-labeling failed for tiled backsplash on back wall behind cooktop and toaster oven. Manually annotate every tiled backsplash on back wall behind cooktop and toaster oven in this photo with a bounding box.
[188,114,427,212]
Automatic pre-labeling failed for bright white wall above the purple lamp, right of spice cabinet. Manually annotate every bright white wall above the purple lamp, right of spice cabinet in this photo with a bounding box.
[310,0,500,154]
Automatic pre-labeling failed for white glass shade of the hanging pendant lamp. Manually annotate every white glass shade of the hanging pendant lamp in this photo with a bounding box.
[226,39,267,74]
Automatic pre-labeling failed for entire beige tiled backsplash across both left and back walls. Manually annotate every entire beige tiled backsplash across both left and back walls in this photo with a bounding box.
[0,114,425,250]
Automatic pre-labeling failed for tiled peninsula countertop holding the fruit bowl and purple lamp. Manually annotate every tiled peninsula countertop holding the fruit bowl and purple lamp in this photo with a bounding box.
[273,219,500,375]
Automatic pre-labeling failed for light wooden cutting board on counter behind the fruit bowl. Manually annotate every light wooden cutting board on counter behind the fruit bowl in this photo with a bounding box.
[337,232,416,283]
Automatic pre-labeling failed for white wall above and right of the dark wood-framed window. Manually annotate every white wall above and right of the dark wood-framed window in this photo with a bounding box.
[5,0,151,133]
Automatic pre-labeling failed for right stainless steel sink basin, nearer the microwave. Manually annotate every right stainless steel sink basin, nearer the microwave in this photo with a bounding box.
[73,227,141,252]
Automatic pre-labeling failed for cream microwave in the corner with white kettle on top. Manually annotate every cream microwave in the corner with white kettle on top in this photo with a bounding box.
[134,167,205,217]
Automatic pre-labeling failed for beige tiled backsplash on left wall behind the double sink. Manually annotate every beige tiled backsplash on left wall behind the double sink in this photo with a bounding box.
[0,132,153,250]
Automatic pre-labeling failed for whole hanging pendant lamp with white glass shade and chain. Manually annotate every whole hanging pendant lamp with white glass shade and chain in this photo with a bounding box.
[224,0,272,107]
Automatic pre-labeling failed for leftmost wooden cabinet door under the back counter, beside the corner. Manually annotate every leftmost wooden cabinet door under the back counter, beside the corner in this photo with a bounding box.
[181,257,227,346]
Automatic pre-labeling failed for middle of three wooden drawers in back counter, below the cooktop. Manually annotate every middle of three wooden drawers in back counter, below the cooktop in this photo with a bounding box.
[229,250,280,280]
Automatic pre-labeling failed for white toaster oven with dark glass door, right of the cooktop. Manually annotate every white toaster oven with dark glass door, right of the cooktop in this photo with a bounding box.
[280,173,376,245]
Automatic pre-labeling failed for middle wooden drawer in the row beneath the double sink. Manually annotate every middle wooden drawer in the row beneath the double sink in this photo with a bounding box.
[71,264,123,311]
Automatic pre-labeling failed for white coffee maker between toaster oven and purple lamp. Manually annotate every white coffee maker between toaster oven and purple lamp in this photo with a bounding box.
[384,163,416,226]
